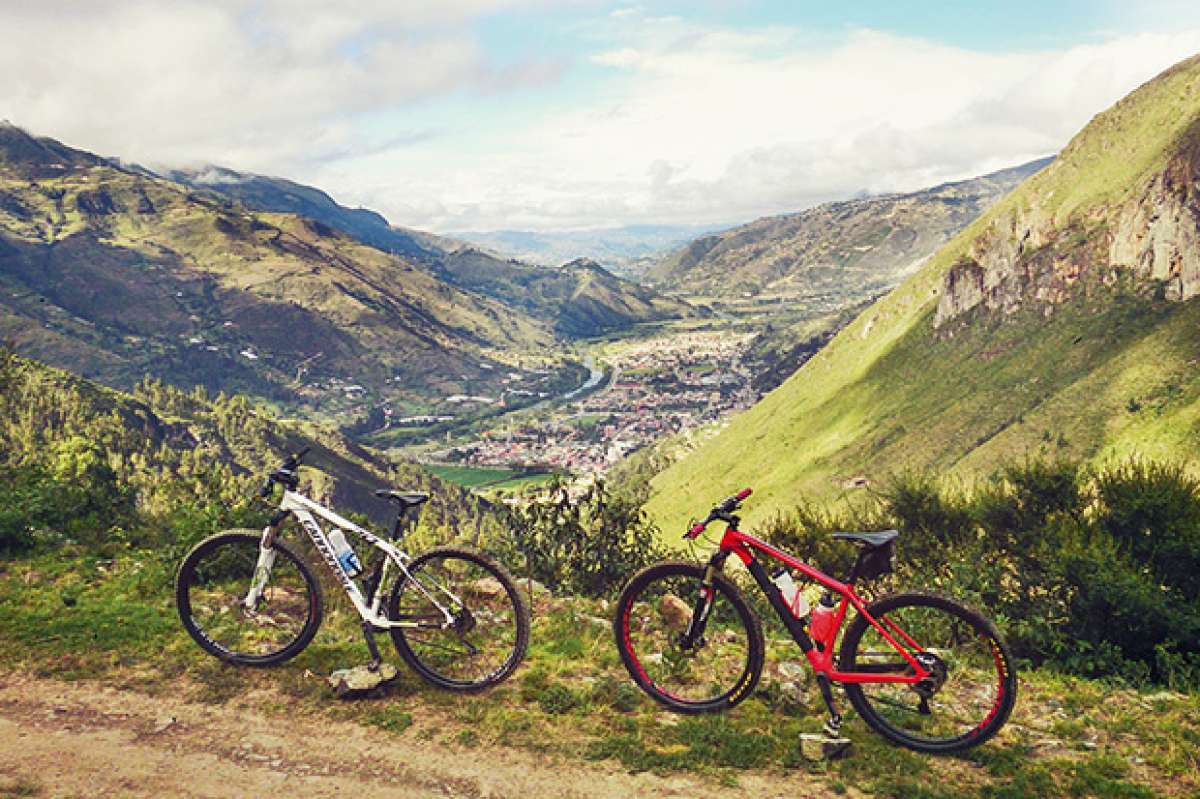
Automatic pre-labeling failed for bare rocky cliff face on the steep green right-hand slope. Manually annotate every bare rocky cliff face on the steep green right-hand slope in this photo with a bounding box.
[934,125,1200,326]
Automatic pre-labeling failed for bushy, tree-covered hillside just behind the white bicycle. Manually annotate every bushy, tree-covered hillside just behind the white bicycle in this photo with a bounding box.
[0,350,485,530]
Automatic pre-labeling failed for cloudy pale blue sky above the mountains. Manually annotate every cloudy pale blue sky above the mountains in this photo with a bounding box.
[0,0,1200,232]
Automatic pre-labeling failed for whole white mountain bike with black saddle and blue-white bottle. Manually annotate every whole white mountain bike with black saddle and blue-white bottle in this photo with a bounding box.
[175,449,529,691]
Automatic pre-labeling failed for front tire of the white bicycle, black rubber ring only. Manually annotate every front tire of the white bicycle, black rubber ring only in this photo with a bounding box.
[175,530,324,667]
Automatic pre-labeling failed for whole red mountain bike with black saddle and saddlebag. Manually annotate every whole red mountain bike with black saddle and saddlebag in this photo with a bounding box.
[613,488,1016,753]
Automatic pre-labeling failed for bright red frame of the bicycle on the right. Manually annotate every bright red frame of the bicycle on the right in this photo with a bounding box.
[689,524,930,685]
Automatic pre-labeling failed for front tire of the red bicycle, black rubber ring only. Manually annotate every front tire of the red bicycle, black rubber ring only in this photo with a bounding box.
[613,560,764,714]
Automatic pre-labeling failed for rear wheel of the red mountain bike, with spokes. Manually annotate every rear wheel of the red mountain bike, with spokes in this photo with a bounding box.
[839,593,1016,753]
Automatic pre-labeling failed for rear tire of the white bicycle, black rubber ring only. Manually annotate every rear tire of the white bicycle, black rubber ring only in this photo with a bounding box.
[388,547,530,693]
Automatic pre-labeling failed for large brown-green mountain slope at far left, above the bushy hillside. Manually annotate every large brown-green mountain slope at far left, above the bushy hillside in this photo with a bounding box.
[0,125,553,410]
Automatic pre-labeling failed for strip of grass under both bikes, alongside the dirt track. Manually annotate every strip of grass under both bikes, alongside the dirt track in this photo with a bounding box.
[0,553,1200,799]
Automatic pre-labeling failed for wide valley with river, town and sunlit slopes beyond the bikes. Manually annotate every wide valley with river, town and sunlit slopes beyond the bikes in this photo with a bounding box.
[0,124,1056,494]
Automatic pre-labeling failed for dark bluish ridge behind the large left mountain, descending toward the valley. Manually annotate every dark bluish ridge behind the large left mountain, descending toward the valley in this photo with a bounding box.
[167,161,694,337]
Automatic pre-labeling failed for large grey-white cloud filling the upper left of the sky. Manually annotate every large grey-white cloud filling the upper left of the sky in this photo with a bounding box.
[0,0,557,172]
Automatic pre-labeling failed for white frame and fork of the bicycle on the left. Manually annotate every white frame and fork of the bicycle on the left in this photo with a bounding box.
[242,489,462,630]
